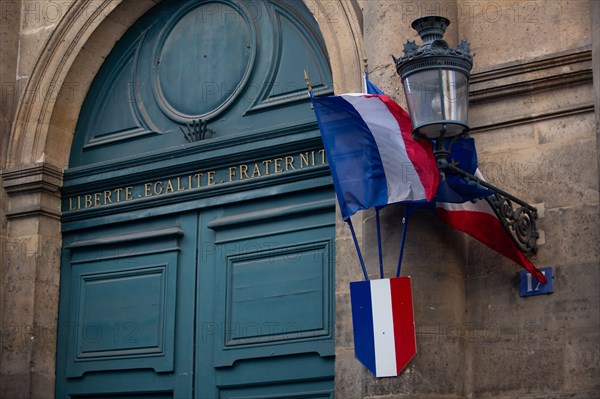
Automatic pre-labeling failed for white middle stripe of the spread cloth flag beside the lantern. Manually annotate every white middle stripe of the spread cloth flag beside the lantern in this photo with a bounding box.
[342,95,425,203]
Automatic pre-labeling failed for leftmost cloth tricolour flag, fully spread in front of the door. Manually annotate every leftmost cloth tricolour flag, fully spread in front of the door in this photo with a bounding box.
[313,94,439,220]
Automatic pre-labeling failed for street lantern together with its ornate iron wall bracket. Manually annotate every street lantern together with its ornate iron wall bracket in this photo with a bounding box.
[392,16,539,253]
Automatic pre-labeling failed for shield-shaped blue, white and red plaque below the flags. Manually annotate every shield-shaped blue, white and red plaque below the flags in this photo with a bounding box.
[350,277,417,377]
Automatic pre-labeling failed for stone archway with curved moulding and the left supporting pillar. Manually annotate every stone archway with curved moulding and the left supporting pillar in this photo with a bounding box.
[0,0,364,397]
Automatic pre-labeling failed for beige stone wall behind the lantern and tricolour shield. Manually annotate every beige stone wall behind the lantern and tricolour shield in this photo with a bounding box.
[336,0,600,398]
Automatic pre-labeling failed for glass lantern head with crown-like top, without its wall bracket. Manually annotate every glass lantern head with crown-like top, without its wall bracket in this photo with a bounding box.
[394,16,473,139]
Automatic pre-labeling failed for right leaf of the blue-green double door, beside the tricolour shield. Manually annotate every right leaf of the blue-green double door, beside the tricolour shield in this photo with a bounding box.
[197,189,335,398]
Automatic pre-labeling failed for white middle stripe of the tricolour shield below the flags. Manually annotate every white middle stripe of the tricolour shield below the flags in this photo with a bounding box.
[371,279,398,377]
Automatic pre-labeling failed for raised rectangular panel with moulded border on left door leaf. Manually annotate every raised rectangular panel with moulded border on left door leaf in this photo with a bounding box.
[67,254,177,377]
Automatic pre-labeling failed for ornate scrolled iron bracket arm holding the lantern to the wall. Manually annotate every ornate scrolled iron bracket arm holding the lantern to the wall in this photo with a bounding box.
[438,163,539,254]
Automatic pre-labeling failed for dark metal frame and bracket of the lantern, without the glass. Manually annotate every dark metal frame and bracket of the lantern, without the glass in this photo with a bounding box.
[392,16,539,254]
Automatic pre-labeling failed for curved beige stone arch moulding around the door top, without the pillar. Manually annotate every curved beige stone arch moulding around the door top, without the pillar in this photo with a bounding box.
[7,0,364,167]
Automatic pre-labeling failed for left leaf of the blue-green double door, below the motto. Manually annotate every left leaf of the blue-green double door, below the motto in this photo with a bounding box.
[57,214,197,397]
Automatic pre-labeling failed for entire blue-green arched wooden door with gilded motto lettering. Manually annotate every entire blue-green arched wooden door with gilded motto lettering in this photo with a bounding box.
[56,0,335,398]
